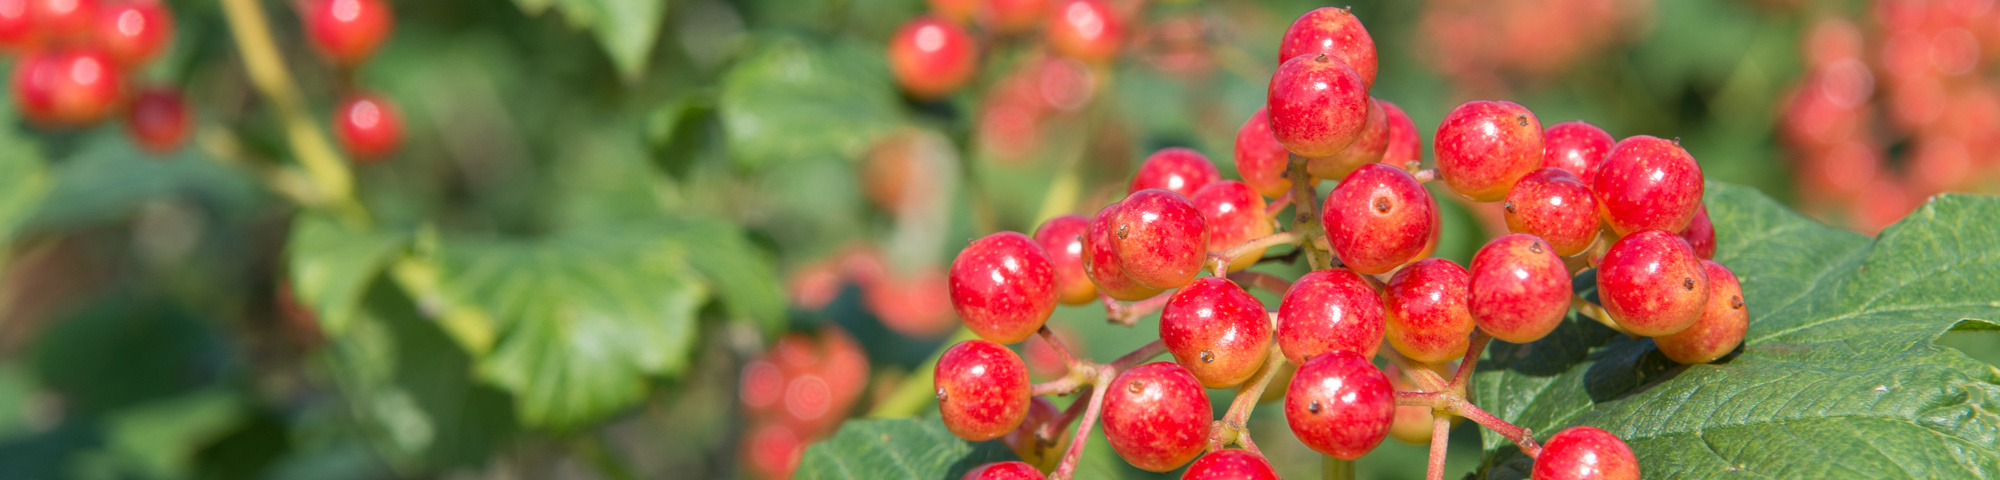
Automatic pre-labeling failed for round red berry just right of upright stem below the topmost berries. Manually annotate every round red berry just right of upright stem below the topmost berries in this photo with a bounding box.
[1320,164,1438,274]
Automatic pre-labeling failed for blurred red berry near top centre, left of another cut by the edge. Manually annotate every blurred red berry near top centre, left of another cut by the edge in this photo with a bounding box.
[888,16,978,100]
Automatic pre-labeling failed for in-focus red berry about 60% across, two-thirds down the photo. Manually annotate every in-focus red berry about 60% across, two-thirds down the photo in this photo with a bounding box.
[1160,276,1272,388]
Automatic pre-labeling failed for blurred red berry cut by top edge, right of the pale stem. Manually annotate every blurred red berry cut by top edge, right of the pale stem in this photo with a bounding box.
[300,0,396,66]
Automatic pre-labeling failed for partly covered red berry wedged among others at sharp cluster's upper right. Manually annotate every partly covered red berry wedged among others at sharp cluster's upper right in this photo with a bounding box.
[1500,166,1598,256]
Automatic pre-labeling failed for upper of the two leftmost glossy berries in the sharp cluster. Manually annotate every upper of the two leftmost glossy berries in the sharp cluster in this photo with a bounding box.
[950,232,1056,344]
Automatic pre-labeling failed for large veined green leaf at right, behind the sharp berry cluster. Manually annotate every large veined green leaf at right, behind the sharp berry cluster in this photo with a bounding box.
[1474,184,2000,478]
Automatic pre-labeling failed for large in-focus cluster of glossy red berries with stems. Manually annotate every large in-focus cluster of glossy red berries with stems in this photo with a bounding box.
[934,8,1748,478]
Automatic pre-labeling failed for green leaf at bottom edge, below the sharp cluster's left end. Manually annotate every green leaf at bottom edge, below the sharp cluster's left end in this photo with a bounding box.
[794,418,1020,480]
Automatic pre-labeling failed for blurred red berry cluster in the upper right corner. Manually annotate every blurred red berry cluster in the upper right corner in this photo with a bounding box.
[1778,0,2000,232]
